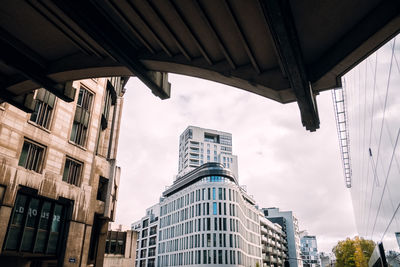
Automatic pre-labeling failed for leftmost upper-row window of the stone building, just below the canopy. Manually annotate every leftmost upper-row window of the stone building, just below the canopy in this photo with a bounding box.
[30,88,56,129]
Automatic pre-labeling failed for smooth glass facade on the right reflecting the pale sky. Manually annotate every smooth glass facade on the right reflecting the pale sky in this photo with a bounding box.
[340,33,400,251]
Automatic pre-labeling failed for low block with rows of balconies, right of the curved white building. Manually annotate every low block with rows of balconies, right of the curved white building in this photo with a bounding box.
[259,217,288,267]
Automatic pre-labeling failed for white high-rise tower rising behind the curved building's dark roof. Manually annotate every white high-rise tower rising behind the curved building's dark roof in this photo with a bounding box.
[178,126,238,179]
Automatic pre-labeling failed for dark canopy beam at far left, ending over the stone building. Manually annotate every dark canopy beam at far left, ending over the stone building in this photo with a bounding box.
[0,28,74,102]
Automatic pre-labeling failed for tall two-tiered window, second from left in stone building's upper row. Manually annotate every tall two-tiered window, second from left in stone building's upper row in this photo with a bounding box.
[70,88,93,146]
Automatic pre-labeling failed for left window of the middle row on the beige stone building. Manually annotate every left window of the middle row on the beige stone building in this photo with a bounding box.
[18,140,45,173]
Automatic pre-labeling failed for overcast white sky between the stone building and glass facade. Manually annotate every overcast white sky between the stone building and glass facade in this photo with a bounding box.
[116,74,356,252]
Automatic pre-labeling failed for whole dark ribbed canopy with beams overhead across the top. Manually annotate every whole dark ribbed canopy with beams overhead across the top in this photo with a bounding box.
[0,0,400,131]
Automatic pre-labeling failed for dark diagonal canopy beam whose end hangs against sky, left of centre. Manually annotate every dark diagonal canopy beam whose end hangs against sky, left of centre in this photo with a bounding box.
[54,0,170,99]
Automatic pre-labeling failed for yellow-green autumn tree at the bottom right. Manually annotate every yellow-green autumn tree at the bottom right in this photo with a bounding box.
[332,236,375,267]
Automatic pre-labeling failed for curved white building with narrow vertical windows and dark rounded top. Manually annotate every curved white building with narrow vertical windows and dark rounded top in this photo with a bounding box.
[157,163,261,267]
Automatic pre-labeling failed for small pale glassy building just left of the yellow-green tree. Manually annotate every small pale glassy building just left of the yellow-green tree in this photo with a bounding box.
[300,231,321,267]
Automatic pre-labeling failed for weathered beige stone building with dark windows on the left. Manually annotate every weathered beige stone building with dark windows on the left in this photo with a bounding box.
[0,77,127,266]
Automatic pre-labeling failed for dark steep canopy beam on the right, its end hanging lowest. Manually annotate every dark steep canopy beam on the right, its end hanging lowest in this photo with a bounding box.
[260,0,319,131]
